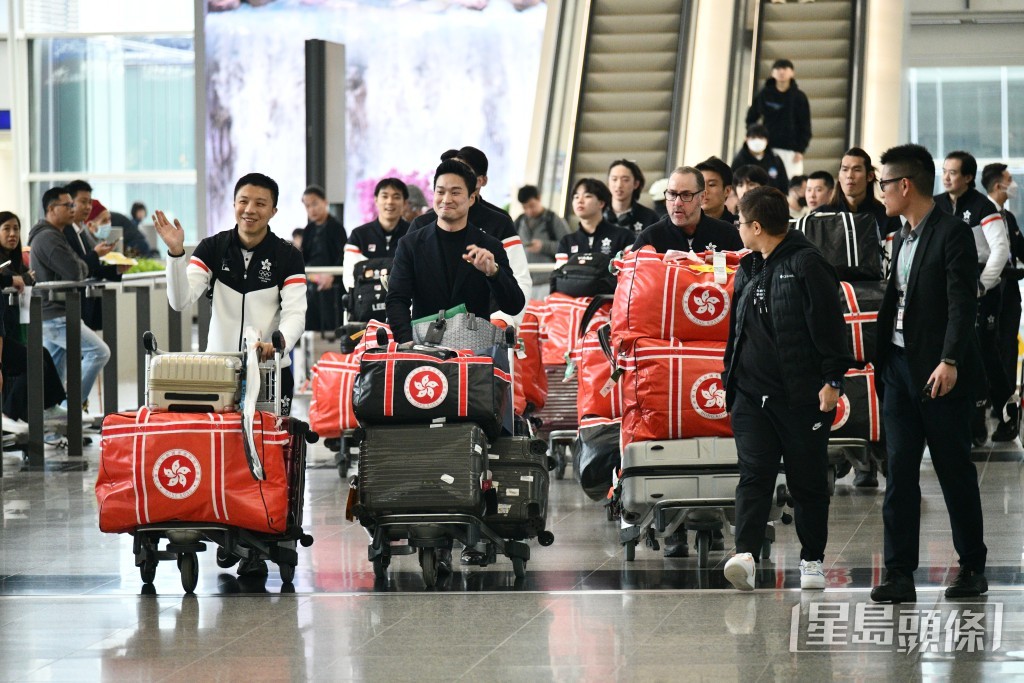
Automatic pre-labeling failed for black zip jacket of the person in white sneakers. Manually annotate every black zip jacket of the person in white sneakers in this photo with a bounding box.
[722,230,854,409]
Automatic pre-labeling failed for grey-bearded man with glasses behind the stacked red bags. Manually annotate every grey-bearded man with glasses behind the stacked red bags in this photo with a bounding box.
[633,166,743,254]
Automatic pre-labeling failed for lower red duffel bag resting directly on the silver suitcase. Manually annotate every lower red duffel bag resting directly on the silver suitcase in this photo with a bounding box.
[620,338,732,446]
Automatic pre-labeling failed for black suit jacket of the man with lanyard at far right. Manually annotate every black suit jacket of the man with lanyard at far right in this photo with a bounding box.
[874,206,984,397]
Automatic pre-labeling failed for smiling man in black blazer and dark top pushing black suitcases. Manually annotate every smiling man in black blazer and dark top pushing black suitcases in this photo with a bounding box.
[386,160,526,343]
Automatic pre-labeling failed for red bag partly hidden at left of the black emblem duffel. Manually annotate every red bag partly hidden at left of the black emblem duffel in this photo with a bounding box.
[309,351,359,438]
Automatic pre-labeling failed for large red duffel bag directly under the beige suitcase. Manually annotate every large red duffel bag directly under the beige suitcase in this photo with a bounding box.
[96,408,289,533]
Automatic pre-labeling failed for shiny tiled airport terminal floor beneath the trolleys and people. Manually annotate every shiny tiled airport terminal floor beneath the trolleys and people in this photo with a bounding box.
[0,387,1024,683]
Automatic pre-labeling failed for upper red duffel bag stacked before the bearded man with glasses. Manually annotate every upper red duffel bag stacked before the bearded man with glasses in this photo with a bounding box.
[611,246,736,348]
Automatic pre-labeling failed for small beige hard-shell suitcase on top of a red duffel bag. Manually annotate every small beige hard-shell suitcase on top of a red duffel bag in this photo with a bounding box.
[146,353,242,413]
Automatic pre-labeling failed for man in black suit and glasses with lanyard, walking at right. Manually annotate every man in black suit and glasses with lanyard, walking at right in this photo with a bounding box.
[871,144,988,602]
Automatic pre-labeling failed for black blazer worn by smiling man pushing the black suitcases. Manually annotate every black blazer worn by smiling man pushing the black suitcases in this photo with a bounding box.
[386,221,526,343]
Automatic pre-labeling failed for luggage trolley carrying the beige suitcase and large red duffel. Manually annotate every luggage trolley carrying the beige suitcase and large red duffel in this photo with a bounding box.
[132,331,317,593]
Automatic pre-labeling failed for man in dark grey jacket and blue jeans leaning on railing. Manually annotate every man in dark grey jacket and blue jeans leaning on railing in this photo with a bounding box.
[29,187,112,419]
